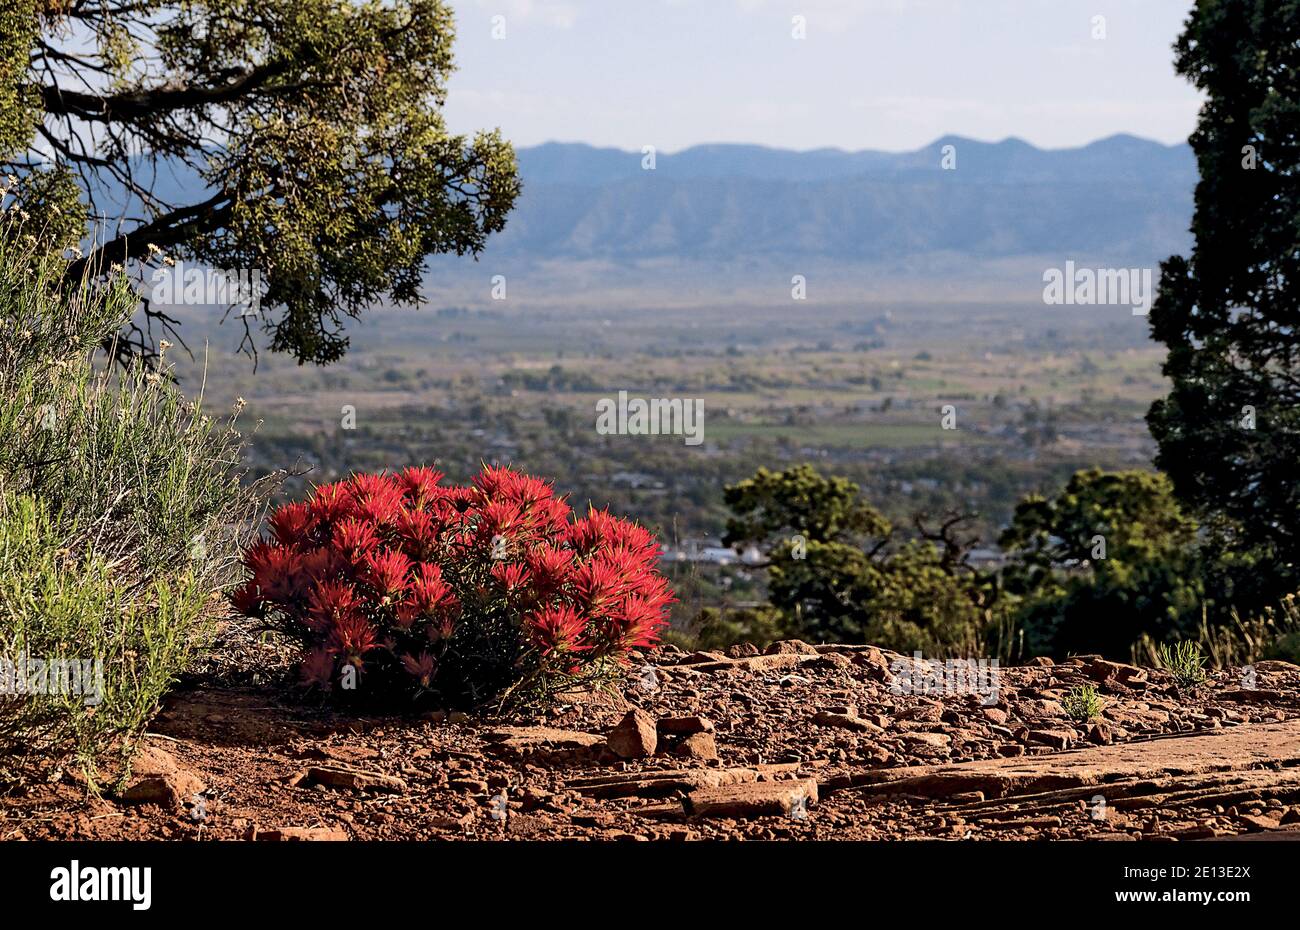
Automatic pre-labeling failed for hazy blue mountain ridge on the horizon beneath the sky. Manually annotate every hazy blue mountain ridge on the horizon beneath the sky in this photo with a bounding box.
[488,135,1197,263]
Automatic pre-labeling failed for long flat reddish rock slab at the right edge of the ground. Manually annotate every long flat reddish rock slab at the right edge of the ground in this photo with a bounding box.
[823,721,1300,797]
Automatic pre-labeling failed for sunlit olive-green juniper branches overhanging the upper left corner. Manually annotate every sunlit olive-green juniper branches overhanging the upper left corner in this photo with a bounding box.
[0,0,520,364]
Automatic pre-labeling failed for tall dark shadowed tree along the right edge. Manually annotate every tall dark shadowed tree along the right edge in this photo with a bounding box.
[1148,0,1300,575]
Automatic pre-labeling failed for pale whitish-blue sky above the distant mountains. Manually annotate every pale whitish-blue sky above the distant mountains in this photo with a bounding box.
[445,0,1200,152]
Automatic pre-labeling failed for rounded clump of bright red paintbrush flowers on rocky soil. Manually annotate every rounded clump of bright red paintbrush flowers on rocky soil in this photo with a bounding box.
[231,467,673,701]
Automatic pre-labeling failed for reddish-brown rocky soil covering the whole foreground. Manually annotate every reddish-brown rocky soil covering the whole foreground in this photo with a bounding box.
[0,641,1300,840]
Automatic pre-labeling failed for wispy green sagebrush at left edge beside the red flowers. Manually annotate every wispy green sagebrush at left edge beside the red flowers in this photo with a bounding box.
[0,209,257,782]
